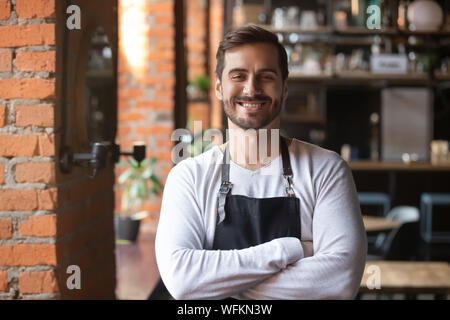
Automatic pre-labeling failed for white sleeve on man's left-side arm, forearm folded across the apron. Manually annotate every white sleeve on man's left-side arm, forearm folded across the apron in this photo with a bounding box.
[155,160,303,299]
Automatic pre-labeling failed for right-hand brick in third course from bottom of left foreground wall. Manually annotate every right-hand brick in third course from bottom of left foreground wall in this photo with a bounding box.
[18,214,56,237]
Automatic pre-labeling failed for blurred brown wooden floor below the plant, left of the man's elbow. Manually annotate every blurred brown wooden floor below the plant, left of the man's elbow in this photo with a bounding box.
[116,233,159,300]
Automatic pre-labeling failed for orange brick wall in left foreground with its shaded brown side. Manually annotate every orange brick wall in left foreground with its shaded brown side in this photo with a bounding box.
[0,0,115,299]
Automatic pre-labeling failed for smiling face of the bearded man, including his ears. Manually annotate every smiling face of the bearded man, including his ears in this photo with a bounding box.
[215,43,287,129]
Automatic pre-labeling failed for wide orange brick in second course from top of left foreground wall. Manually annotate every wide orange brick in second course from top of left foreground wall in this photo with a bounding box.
[0,24,55,48]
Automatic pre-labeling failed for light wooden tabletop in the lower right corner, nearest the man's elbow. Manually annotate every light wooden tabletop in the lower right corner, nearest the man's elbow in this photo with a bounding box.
[360,261,450,295]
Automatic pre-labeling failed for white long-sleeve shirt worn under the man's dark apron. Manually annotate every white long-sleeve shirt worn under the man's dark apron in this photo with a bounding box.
[155,139,367,299]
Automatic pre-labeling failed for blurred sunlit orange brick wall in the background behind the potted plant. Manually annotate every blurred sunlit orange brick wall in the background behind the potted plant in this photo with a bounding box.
[116,0,175,232]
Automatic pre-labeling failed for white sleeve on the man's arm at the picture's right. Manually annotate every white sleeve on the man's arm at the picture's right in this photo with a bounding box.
[237,155,367,299]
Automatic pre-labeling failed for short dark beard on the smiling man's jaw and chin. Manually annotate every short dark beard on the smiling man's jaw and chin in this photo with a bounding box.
[223,96,283,130]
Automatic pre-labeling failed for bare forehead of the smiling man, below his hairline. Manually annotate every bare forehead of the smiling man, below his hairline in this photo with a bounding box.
[224,43,280,71]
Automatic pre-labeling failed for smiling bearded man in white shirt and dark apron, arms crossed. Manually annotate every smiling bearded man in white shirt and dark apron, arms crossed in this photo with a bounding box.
[155,25,367,299]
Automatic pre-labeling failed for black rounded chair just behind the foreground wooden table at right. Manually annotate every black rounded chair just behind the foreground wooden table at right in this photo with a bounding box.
[367,221,420,261]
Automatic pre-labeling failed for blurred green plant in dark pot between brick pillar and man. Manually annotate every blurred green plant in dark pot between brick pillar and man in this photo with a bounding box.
[115,158,162,242]
